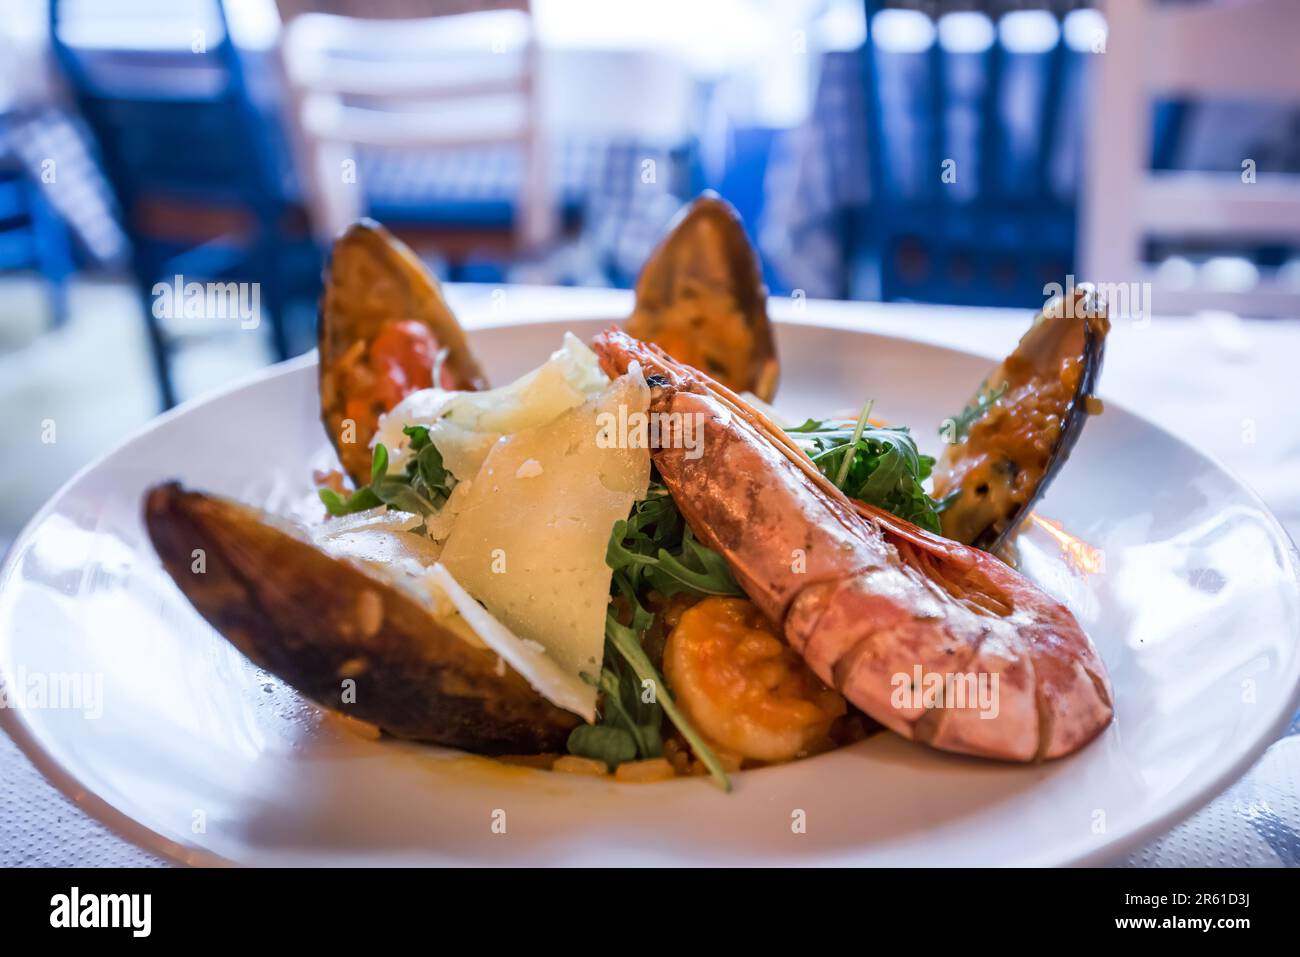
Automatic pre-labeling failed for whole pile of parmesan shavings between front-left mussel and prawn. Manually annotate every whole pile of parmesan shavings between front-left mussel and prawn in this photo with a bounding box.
[327,335,650,720]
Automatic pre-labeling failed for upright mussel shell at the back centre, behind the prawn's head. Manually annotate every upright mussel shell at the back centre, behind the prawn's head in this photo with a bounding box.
[627,191,780,402]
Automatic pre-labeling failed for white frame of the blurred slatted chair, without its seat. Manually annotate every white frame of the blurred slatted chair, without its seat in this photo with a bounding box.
[281,0,558,250]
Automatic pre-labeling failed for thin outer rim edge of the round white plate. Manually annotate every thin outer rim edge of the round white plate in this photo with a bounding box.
[0,313,1300,867]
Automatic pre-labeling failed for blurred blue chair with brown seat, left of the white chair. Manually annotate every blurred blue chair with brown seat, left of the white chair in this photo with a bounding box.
[49,0,320,407]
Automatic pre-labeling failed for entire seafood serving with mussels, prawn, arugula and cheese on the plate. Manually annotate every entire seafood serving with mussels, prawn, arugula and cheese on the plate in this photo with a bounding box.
[143,194,1114,789]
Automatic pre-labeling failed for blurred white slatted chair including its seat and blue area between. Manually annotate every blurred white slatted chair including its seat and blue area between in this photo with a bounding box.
[281,0,561,273]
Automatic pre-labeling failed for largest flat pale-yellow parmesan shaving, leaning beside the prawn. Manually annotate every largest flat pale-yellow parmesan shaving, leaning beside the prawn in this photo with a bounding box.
[441,374,650,719]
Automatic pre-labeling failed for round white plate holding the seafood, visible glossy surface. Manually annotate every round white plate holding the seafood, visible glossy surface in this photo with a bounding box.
[0,321,1300,865]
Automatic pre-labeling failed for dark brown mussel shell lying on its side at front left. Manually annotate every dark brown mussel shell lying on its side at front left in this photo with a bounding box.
[144,482,581,754]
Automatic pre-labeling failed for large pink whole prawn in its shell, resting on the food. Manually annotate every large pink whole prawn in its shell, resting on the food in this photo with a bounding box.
[595,330,1113,761]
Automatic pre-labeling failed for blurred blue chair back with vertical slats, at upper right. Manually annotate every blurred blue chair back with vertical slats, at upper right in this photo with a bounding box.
[852,0,1083,307]
